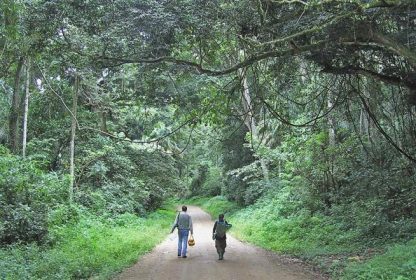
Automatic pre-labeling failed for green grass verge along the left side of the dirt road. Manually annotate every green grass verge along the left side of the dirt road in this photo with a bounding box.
[0,210,174,279]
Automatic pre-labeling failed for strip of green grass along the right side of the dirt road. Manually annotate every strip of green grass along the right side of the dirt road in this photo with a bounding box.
[187,196,416,280]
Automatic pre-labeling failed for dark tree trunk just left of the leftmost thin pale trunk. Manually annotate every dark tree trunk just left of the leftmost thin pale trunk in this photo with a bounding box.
[9,57,23,152]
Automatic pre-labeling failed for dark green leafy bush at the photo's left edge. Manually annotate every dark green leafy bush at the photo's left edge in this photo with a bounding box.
[0,150,69,244]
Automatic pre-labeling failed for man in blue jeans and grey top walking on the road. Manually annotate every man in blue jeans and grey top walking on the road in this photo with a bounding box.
[170,205,194,258]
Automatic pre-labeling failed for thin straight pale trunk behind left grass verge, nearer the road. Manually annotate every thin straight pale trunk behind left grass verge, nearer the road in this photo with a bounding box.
[69,75,79,201]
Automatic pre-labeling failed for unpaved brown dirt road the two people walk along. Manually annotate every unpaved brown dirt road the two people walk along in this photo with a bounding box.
[117,206,324,280]
